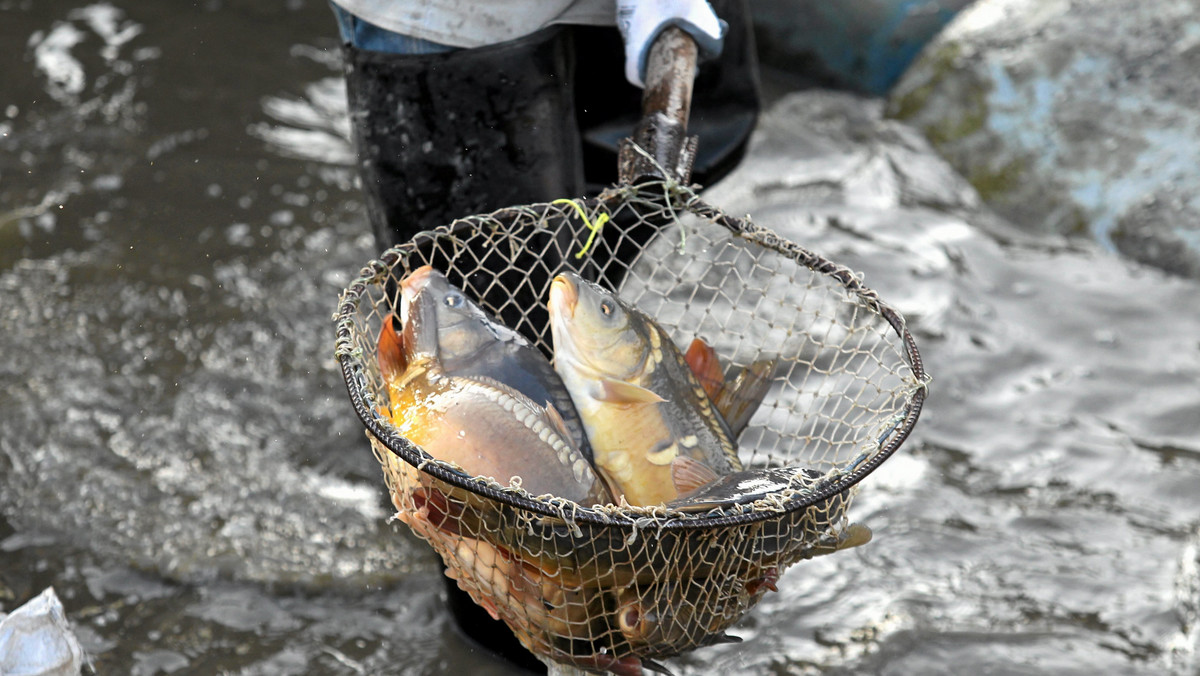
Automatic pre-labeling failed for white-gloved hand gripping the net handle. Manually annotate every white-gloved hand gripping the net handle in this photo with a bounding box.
[617,0,727,88]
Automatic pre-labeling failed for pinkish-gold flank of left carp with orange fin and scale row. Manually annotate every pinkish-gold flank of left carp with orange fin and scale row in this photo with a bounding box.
[378,274,612,505]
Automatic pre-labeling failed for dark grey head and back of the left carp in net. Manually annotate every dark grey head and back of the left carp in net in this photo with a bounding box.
[401,265,592,462]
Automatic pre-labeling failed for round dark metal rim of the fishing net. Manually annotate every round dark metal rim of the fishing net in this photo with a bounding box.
[334,181,929,530]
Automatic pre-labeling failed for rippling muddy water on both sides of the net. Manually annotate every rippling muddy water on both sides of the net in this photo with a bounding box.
[0,0,1200,675]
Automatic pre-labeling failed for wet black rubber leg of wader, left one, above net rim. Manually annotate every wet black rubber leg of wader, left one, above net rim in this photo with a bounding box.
[344,26,583,250]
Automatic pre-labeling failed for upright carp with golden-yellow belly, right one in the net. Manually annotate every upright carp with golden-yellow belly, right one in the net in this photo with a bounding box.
[548,273,742,505]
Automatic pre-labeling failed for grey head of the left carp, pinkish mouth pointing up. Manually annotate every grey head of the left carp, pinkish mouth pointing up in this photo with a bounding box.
[401,265,528,371]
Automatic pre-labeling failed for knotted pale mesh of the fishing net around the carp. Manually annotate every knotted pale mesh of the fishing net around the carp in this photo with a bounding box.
[335,183,928,674]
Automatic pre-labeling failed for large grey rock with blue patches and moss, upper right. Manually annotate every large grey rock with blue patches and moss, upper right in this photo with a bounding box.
[888,0,1200,277]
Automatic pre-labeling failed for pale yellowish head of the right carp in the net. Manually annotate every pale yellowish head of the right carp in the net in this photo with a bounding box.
[548,273,652,382]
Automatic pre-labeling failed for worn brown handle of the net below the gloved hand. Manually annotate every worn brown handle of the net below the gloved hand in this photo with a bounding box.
[617,26,698,185]
